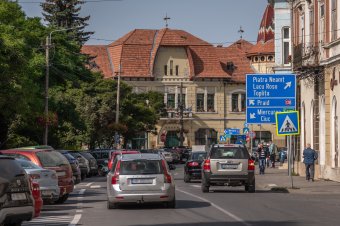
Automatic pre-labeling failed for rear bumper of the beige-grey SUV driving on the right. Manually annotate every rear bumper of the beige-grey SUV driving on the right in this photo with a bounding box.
[203,172,255,186]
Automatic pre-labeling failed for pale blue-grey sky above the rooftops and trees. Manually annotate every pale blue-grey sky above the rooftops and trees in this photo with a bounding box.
[19,0,268,46]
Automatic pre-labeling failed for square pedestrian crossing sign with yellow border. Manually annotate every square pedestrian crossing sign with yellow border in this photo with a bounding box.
[275,111,300,136]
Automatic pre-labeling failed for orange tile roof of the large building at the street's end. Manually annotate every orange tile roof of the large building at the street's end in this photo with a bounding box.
[83,28,253,82]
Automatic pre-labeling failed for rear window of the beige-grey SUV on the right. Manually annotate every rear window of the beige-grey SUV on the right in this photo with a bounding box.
[210,147,249,159]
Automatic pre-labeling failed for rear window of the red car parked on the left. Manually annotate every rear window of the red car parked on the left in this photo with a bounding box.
[37,151,69,167]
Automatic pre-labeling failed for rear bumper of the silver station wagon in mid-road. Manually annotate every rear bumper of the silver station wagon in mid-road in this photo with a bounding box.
[108,185,175,203]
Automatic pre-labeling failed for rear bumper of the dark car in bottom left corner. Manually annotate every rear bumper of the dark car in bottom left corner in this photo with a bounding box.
[0,206,34,224]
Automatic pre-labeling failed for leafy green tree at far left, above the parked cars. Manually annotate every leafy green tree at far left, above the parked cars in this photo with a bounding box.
[0,0,45,148]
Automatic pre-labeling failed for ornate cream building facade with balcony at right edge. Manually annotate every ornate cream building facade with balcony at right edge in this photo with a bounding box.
[291,0,340,181]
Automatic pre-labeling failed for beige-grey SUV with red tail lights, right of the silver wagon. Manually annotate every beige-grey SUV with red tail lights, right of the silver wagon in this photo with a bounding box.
[201,144,255,192]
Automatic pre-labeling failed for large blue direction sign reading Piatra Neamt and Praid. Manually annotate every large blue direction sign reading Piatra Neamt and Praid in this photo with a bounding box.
[246,74,296,124]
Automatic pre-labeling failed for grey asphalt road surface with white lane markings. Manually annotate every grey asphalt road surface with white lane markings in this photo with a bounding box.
[23,165,340,226]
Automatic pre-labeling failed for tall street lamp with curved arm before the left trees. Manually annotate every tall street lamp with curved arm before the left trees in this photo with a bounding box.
[44,27,77,145]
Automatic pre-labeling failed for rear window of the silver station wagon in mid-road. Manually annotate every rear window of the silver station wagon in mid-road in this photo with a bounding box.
[120,159,163,175]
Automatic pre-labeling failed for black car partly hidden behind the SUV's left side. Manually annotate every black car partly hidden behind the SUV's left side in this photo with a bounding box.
[184,151,207,183]
